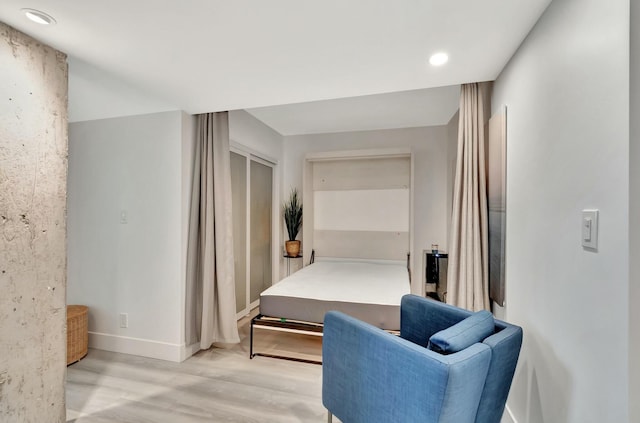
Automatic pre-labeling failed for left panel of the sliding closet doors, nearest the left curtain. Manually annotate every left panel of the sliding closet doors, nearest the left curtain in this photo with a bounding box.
[231,152,247,313]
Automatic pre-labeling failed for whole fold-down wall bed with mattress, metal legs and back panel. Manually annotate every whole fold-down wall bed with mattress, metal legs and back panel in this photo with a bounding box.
[249,149,413,361]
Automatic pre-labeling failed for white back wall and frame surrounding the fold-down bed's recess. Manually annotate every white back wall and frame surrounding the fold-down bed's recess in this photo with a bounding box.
[283,126,450,293]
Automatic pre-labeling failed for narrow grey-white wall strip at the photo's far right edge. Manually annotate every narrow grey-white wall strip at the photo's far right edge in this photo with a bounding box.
[629,1,640,422]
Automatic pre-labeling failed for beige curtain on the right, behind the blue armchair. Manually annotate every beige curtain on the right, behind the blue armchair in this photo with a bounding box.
[447,83,490,310]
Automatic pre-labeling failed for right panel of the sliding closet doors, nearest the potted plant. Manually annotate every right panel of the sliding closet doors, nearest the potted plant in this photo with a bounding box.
[250,160,273,304]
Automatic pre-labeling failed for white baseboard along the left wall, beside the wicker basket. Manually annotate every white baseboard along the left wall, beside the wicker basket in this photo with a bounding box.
[89,332,195,362]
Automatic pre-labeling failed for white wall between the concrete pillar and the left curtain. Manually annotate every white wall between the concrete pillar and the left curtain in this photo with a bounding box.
[68,111,189,361]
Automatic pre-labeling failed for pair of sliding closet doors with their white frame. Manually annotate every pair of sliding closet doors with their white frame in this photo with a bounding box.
[231,151,273,317]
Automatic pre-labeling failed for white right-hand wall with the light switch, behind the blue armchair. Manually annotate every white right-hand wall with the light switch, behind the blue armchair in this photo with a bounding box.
[493,0,637,423]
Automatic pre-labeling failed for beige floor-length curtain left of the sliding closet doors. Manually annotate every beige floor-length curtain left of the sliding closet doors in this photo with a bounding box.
[185,112,240,349]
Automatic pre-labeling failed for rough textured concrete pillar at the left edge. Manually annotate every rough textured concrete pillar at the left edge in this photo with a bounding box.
[0,23,67,422]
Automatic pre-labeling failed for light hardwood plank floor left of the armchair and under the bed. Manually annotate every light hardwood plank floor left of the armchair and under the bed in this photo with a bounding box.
[67,320,330,423]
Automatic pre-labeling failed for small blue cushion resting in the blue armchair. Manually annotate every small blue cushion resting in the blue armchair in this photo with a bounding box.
[427,310,495,354]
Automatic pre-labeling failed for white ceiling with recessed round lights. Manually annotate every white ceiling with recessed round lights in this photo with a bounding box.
[0,0,551,134]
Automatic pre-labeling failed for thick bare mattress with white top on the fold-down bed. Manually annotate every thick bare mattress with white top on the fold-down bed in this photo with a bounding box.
[260,260,410,330]
